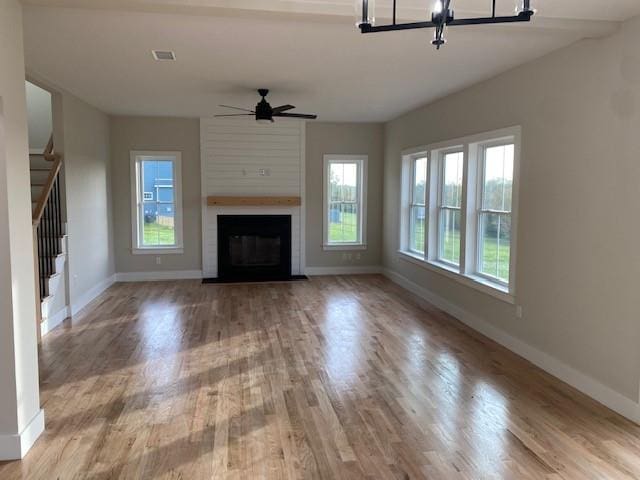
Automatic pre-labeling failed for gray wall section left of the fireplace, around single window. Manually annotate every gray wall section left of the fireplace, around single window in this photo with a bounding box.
[111,117,202,273]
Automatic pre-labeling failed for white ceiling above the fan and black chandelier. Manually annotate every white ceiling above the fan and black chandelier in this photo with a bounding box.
[24,0,640,121]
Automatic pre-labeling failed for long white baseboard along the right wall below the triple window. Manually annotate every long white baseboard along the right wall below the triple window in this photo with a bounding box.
[382,268,640,423]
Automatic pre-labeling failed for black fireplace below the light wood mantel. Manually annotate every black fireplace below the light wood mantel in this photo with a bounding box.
[218,215,291,281]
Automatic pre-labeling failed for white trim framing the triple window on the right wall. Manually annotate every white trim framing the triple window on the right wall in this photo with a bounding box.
[398,126,522,304]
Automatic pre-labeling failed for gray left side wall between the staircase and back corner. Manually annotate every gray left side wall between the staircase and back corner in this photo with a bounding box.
[61,93,115,306]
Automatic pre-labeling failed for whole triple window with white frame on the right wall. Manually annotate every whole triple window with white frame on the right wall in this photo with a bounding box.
[400,127,521,303]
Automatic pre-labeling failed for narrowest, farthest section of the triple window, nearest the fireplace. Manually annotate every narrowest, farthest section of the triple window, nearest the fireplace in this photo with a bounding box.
[409,157,427,254]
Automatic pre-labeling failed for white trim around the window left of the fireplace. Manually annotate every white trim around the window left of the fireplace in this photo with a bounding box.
[130,150,184,255]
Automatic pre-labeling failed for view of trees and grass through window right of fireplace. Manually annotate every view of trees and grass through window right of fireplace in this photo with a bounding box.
[329,162,360,243]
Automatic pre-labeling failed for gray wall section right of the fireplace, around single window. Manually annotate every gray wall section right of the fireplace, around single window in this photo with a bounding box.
[305,122,384,267]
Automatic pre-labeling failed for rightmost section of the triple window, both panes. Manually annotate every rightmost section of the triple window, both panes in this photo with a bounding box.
[477,143,514,284]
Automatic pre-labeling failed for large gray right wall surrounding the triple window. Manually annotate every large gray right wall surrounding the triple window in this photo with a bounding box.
[383,15,640,400]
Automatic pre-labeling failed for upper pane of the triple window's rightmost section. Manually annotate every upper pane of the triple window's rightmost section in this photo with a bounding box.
[482,145,514,212]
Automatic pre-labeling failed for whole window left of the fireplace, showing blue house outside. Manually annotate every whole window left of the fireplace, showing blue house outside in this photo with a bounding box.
[131,152,182,254]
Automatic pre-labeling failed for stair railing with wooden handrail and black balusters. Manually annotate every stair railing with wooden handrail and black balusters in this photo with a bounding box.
[32,137,65,316]
